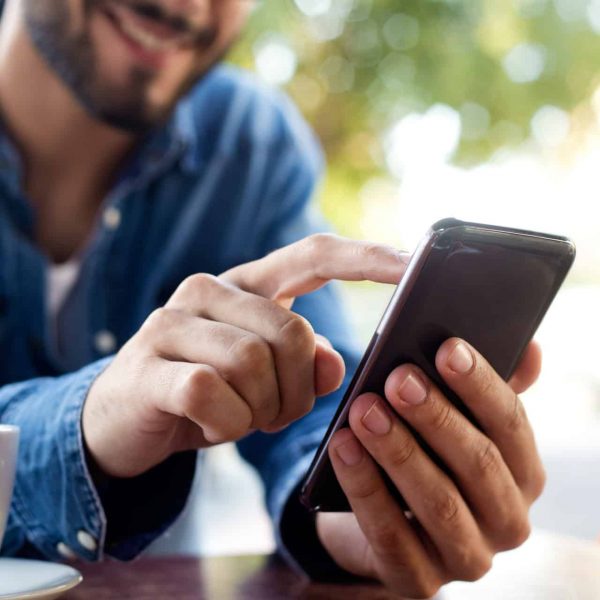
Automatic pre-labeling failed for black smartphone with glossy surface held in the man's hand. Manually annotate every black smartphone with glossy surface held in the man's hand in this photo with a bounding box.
[300,219,575,512]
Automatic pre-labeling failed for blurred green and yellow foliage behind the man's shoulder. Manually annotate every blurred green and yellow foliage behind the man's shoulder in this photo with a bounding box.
[227,0,600,234]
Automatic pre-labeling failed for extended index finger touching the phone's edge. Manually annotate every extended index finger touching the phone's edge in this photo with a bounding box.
[221,233,409,308]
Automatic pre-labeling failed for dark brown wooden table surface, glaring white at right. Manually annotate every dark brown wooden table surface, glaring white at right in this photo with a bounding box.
[63,532,600,600]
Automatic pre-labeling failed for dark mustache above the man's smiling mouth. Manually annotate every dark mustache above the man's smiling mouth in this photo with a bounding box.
[94,0,219,47]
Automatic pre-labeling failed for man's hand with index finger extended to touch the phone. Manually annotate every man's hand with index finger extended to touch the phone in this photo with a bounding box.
[83,234,407,477]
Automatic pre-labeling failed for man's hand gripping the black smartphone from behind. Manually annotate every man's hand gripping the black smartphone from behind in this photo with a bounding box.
[317,338,545,598]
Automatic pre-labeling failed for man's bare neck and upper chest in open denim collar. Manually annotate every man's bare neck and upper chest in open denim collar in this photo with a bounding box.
[0,0,137,262]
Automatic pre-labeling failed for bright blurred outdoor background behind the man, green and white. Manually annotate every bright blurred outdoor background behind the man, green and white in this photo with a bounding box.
[151,0,600,554]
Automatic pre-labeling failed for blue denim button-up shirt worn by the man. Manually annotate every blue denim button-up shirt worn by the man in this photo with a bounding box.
[0,66,357,565]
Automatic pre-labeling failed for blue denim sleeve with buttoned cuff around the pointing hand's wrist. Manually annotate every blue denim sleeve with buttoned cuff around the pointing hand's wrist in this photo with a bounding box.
[0,358,196,561]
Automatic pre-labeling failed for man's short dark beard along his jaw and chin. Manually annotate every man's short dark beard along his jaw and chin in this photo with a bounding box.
[22,0,224,134]
